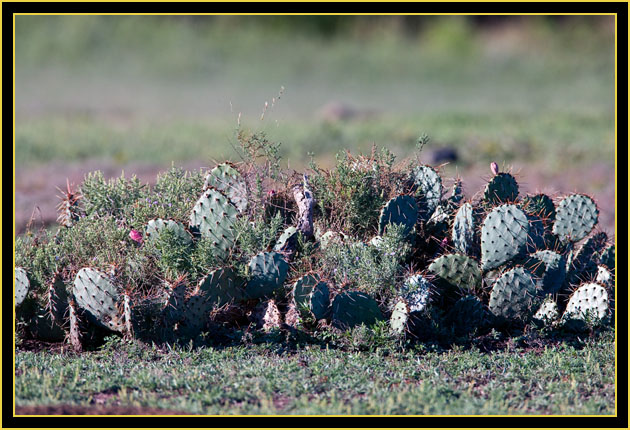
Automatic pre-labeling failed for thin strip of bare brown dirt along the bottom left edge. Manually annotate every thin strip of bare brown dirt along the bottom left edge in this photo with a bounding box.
[15,405,192,415]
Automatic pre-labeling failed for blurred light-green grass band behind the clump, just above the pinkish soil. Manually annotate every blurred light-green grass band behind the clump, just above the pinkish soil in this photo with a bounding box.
[16,112,614,168]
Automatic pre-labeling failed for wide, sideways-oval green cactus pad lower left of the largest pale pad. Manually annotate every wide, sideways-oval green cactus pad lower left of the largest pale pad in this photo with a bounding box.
[429,254,481,294]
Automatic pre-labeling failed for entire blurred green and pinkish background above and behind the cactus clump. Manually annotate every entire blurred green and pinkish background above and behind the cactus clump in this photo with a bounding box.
[15,16,615,235]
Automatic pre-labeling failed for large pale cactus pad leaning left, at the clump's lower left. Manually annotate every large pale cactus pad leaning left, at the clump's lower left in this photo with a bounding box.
[74,267,125,332]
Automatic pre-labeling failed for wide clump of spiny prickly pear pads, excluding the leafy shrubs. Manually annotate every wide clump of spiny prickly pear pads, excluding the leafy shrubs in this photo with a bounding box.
[15,150,615,348]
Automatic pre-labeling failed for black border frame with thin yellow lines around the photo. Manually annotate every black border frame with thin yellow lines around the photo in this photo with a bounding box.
[2,2,628,428]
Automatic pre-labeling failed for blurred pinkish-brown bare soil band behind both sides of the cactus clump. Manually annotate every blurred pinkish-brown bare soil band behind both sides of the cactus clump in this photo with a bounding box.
[15,161,615,237]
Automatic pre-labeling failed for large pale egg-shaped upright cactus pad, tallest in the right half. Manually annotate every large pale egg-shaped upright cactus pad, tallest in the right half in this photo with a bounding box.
[481,205,529,271]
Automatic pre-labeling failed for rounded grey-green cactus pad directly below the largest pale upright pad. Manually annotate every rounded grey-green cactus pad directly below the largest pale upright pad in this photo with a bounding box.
[488,267,539,324]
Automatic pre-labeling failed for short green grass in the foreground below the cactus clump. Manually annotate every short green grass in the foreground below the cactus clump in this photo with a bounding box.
[15,331,615,415]
